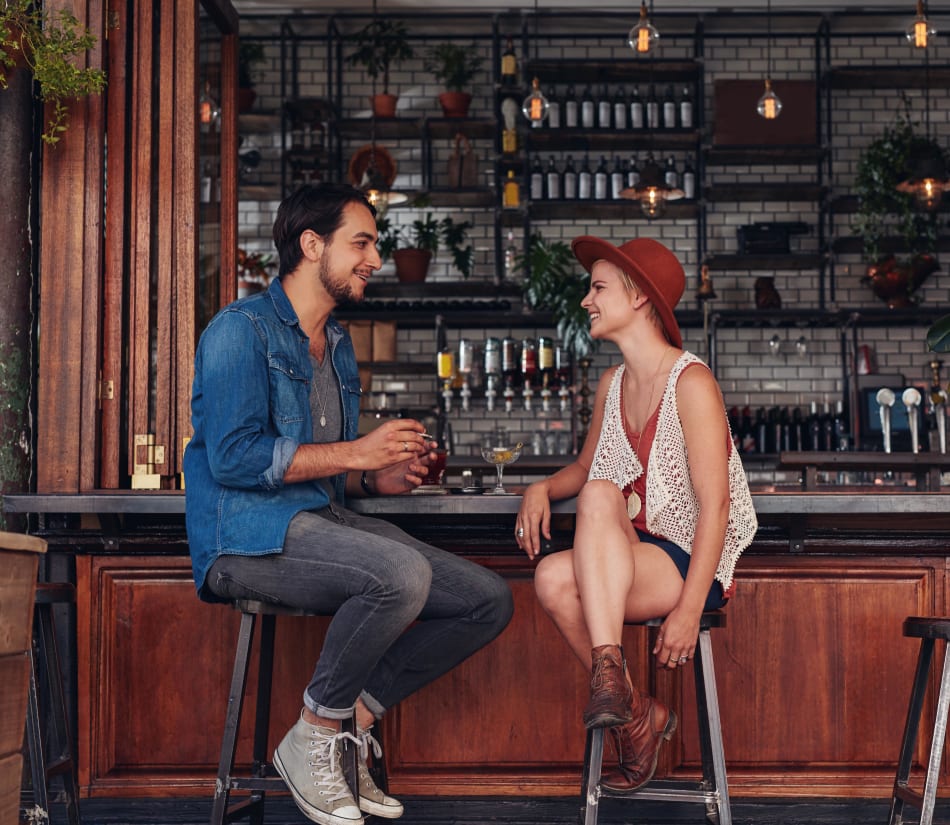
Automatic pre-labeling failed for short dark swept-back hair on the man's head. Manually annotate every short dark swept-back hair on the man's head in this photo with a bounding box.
[274,183,376,277]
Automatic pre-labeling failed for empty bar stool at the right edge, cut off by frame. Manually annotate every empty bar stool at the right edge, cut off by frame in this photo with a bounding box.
[887,616,950,825]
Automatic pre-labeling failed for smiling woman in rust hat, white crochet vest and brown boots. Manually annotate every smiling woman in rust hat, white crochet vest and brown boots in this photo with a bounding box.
[515,236,757,791]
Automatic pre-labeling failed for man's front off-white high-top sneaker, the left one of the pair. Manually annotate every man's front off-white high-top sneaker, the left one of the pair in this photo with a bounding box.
[274,713,366,825]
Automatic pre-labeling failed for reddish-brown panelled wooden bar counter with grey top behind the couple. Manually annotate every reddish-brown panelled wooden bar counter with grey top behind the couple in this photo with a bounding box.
[4,489,950,798]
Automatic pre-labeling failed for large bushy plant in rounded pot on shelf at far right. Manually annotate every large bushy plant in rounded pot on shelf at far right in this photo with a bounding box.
[852,100,942,307]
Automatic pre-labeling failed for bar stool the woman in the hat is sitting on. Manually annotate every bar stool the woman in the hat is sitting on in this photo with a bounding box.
[581,610,732,825]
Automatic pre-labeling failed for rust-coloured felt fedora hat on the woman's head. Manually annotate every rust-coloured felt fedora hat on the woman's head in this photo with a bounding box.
[571,235,686,347]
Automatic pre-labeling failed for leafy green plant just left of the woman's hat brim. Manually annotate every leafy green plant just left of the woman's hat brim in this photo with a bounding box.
[515,233,599,359]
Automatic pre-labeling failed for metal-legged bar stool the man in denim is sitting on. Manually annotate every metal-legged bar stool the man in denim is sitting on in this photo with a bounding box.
[211,599,359,825]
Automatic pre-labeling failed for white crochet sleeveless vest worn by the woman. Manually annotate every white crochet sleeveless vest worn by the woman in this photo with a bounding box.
[587,352,758,588]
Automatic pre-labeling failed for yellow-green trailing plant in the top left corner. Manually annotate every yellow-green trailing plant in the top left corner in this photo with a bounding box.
[0,0,106,145]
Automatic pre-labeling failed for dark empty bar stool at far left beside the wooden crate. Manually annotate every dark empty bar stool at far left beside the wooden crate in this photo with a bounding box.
[26,582,82,825]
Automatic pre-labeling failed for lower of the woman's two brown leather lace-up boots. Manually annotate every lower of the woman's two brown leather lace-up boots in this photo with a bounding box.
[600,690,676,792]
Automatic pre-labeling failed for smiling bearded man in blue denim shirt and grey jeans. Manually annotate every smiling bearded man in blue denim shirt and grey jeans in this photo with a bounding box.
[185,185,512,825]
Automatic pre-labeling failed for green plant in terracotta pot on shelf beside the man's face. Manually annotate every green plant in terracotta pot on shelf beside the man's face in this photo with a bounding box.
[376,206,475,283]
